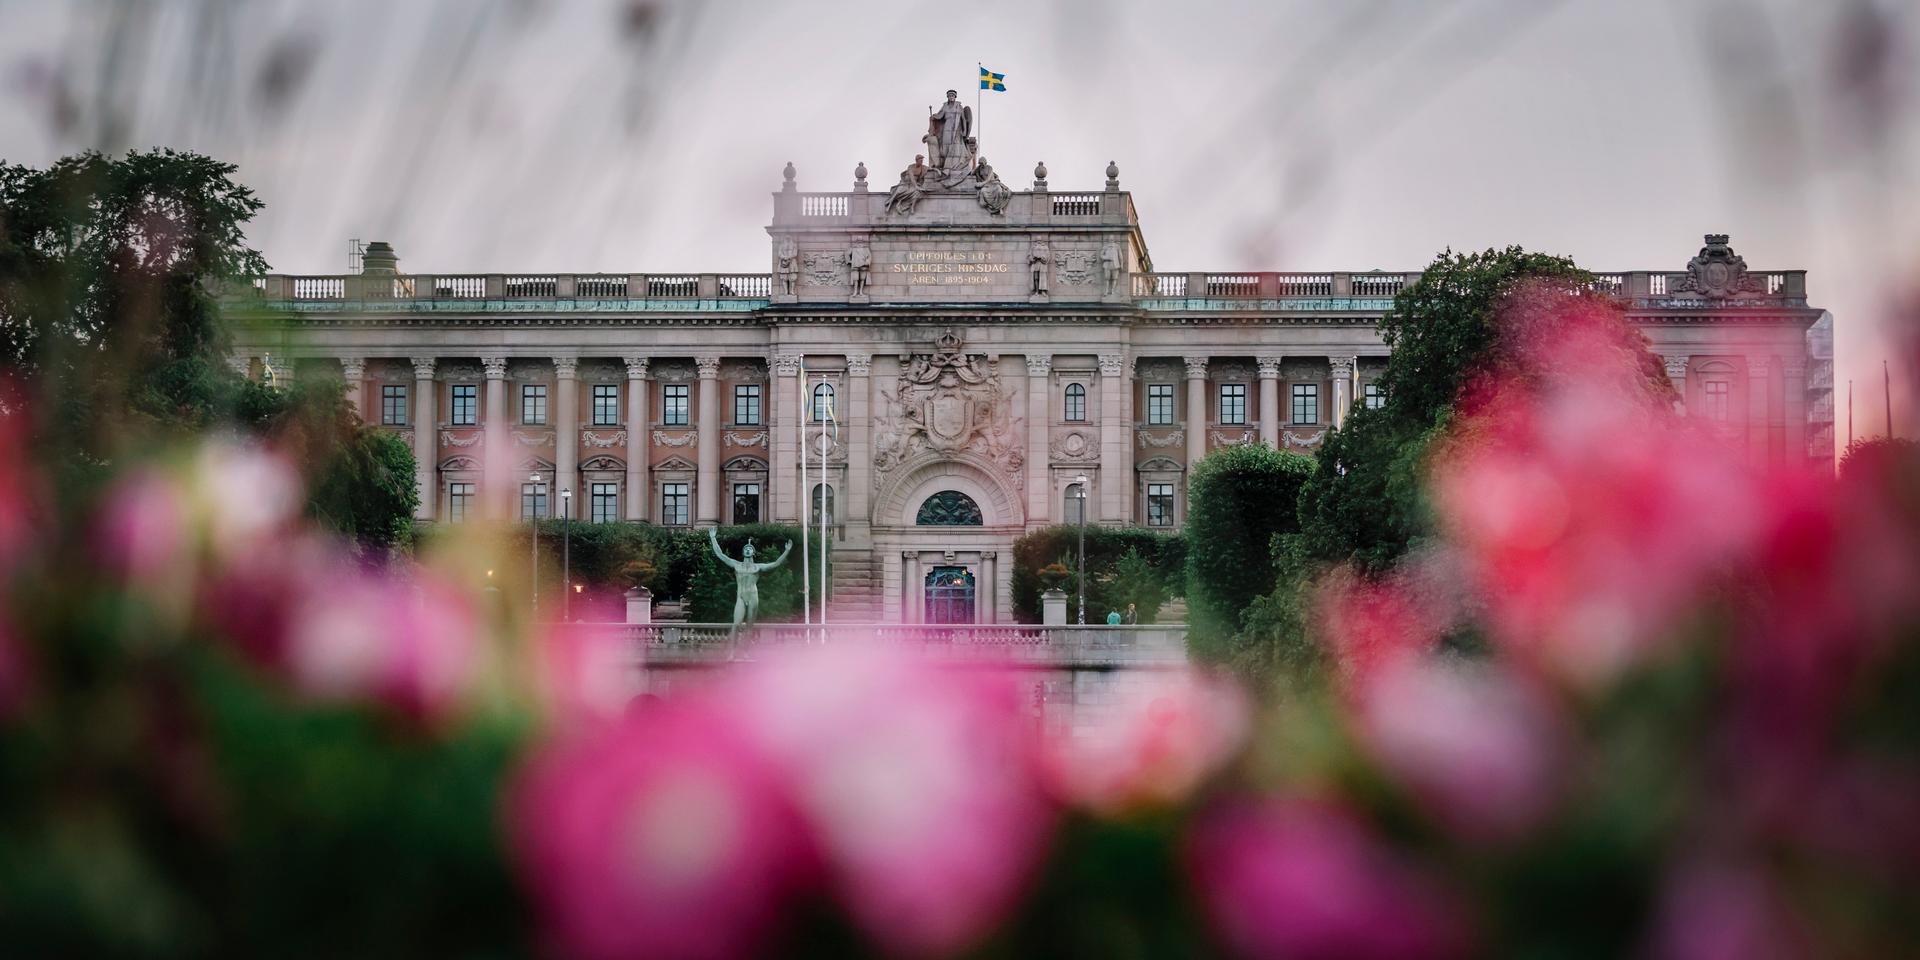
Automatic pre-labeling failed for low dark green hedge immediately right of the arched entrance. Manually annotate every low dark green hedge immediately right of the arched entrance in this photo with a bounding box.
[1012,524,1187,624]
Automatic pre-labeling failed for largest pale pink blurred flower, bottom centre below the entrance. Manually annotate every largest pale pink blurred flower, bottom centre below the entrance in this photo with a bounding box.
[726,643,1048,954]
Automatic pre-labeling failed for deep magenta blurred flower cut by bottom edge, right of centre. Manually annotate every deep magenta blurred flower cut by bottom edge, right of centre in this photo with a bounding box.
[1190,801,1467,960]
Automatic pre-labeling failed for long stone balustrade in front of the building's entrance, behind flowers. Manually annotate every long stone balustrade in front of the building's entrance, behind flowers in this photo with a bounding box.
[582,624,1187,670]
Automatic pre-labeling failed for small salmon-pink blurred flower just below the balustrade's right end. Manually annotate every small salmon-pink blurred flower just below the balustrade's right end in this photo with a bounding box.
[1043,670,1250,816]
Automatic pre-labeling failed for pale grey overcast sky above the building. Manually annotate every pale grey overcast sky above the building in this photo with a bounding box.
[0,0,1920,438]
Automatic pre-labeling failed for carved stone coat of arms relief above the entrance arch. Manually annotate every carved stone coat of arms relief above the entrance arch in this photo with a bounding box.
[874,330,1025,488]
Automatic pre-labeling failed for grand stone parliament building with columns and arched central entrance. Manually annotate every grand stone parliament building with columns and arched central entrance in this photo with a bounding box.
[234,101,1832,622]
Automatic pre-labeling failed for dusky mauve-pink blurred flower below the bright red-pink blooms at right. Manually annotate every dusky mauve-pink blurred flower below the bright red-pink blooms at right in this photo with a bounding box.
[1359,659,1567,841]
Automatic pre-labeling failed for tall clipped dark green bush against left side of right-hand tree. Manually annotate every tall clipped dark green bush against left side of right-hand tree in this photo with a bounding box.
[1187,444,1313,659]
